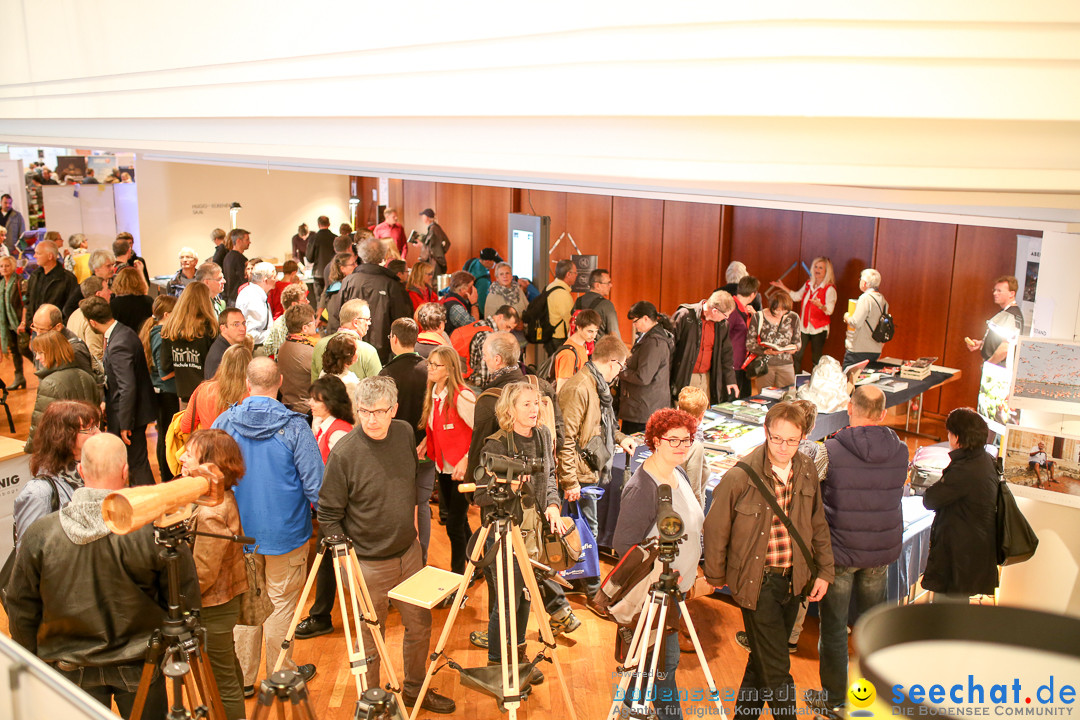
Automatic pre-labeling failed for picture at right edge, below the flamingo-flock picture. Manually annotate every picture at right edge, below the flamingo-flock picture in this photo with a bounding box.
[1002,425,1080,506]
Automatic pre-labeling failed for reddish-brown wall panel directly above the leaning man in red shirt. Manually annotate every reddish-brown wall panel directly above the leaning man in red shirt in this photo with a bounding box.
[659,202,721,315]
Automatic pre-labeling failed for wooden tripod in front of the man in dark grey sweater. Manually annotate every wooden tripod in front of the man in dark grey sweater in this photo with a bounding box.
[271,535,406,720]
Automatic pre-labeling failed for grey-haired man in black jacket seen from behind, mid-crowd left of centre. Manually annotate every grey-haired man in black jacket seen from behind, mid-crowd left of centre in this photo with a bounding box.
[341,237,413,365]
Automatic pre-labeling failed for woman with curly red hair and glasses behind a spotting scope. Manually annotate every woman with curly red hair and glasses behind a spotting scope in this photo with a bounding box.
[611,408,705,718]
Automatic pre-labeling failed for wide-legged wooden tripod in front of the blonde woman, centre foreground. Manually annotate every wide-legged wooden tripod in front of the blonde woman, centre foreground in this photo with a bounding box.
[409,468,578,720]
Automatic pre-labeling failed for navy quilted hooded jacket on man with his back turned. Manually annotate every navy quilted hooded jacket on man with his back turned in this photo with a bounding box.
[821,425,907,568]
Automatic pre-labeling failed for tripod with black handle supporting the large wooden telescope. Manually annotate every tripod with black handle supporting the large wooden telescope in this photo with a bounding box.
[131,521,255,720]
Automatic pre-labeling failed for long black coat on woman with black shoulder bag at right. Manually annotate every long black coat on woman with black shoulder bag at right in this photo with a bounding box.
[922,448,998,595]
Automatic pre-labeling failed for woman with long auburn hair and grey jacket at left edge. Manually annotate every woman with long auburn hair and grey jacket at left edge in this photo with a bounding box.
[13,399,102,547]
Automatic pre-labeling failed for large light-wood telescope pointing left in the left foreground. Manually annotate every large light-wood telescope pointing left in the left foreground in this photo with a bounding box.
[102,463,225,535]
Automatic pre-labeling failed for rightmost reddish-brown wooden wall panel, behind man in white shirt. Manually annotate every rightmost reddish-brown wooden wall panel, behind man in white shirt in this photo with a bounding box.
[937,226,1028,415]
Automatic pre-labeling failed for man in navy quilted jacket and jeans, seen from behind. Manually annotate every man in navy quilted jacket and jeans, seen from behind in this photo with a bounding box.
[808,385,907,718]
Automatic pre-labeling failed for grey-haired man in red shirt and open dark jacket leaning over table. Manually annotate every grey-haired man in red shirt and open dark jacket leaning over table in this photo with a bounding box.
[672,290,739,405]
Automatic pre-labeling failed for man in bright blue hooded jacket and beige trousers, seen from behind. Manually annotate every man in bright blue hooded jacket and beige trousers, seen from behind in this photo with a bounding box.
[214,357,323,692]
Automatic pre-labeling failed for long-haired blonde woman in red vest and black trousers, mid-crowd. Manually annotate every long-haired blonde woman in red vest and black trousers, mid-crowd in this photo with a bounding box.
[419,345,476,573]
